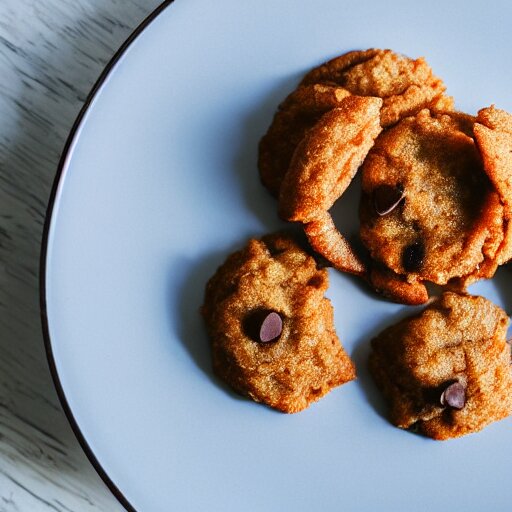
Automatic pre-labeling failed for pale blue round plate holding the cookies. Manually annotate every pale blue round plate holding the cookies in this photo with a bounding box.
[42,0,512,512]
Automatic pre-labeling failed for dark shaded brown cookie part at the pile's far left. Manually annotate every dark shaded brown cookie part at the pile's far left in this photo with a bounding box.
[258,84,350,197]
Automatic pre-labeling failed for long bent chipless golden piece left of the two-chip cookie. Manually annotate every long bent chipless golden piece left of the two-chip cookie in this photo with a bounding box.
[279,96,382,275]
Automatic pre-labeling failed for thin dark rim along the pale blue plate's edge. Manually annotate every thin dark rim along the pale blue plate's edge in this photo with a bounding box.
[39,0,174,512]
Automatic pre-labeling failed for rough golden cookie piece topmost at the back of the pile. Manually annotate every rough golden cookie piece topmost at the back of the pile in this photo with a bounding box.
[301,48,453,127]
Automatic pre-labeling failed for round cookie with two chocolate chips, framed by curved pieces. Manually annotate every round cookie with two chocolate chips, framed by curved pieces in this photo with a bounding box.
[360,109,512,304]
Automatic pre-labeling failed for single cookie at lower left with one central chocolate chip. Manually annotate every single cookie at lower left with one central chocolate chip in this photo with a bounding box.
[202,234,355,413]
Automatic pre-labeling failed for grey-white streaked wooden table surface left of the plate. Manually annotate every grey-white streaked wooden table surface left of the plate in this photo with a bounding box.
[0,0,160,512]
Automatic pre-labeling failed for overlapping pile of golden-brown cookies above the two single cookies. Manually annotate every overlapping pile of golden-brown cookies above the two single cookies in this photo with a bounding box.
[259,49,512,304]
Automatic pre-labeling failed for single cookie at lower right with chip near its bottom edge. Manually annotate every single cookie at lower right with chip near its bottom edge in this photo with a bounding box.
[369,292,512,440]
